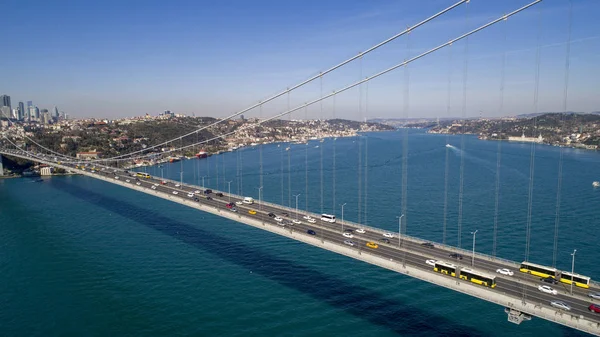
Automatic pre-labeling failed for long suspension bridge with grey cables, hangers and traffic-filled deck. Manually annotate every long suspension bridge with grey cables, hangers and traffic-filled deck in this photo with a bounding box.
[0,0,600,335]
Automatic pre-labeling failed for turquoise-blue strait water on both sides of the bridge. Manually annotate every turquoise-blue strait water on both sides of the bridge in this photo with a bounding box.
[0,131,600,336]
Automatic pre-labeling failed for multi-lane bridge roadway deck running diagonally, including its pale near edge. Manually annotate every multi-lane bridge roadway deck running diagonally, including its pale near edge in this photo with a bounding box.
[0,150,600,336]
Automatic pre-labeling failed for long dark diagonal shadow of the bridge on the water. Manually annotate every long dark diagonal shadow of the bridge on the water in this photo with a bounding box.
[51,179,482,336]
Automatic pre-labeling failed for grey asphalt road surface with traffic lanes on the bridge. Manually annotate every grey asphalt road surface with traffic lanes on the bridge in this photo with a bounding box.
[6,151,600,323]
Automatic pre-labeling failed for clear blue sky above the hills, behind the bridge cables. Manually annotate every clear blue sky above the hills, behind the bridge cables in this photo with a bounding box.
[0,0,600,119]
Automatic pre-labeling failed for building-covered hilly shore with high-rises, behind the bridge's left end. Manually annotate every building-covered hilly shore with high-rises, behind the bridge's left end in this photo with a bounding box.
[0,95,395,169]
